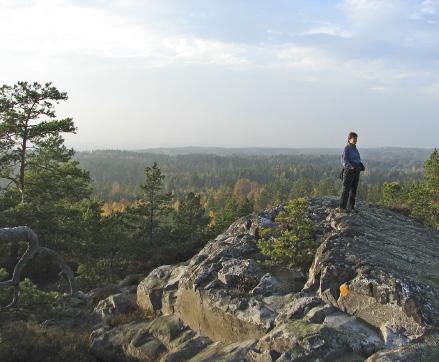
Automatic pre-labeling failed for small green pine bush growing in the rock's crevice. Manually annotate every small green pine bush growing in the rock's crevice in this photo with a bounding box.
[257,198,317,266]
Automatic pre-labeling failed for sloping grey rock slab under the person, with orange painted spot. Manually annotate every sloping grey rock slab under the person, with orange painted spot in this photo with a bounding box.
[306,203,439,341]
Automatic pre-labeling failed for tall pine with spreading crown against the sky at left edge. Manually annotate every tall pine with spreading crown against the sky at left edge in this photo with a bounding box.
[0,82,76,201]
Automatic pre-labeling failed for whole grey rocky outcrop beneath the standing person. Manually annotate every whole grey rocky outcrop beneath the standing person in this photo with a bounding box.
[91,198,439,362]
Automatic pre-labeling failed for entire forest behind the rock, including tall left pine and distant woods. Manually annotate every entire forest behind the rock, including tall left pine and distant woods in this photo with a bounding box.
[0,82,438,288]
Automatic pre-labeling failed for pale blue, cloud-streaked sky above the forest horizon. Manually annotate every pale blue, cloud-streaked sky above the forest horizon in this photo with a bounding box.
[0,0,439,150]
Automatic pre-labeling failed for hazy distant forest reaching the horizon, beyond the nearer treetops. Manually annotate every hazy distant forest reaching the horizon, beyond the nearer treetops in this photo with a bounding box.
[74,147,432,210]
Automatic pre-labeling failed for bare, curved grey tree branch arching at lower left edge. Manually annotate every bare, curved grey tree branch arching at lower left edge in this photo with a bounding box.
[0,226,74,310]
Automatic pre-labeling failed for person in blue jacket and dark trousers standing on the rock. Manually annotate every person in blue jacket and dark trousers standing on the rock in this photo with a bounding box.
[340,132,365,211]
